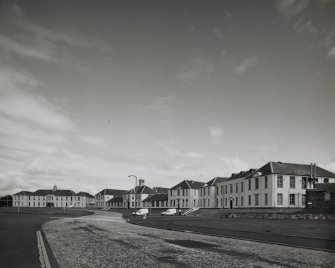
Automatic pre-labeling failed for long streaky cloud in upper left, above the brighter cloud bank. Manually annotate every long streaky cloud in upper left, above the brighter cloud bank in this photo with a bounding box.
[0,4,113,70]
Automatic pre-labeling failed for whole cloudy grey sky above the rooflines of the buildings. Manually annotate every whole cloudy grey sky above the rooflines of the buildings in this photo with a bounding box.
[0,0,335,195]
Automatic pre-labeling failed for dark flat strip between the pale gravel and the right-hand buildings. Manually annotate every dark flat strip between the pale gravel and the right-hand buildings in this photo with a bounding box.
[129,216,335,252]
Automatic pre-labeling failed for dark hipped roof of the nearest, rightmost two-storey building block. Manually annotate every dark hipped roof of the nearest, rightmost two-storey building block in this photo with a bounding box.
[245,162,335,178]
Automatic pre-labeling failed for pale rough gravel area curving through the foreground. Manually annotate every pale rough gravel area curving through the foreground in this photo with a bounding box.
[43,211,335,268]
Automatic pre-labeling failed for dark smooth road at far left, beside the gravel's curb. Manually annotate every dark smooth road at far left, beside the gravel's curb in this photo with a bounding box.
[0,209,92,268]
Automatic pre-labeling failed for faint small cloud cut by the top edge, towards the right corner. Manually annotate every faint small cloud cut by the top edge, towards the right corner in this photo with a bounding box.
[275,0,310,18]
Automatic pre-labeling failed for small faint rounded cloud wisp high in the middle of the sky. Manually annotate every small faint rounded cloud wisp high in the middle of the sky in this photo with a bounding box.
[178,58,214,83]
